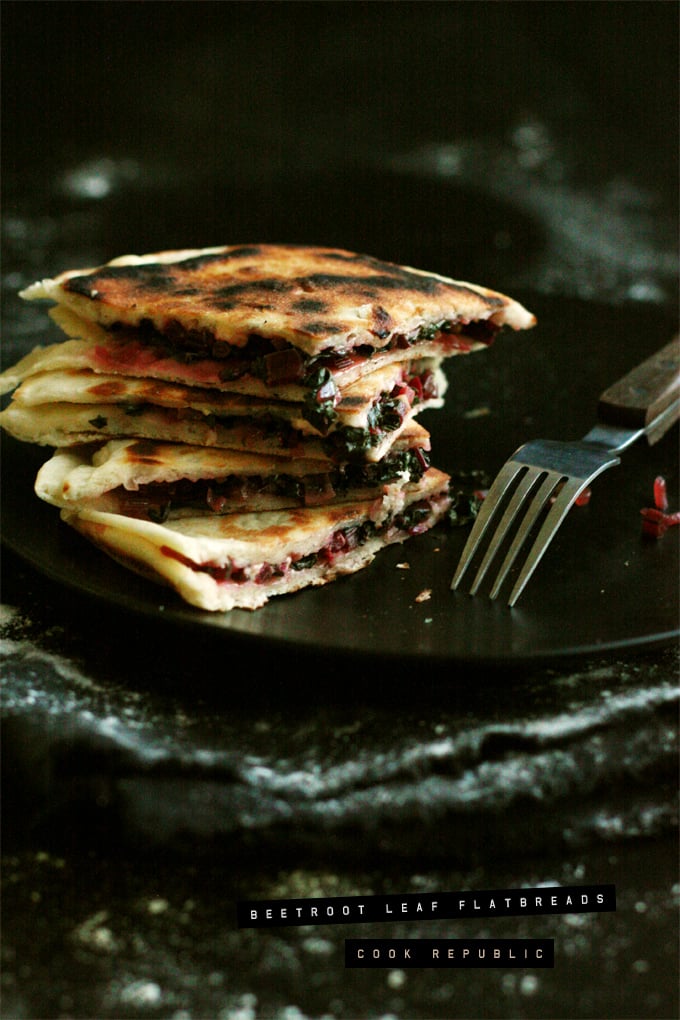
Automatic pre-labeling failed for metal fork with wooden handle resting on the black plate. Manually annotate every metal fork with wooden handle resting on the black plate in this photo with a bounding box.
[451,337,680,606]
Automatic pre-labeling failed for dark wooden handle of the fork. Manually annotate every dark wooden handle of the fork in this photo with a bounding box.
[597,334,680,441]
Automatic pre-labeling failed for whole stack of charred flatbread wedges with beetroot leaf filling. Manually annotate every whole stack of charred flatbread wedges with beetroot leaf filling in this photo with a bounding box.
[0,245,534,611]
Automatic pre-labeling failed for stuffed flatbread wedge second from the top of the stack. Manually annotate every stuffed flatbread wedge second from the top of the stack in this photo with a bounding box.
[0,359,447,461]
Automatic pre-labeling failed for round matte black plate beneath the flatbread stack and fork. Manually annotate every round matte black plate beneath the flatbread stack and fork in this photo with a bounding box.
[2,295,680,664]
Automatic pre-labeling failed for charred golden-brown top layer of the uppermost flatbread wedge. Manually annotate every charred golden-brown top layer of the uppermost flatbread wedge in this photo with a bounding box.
[21,244,535,355]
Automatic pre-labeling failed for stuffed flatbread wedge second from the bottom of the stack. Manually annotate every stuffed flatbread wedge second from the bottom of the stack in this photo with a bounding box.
[35,429,429,522]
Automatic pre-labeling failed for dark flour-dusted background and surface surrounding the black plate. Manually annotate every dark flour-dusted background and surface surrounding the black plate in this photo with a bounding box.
[0,0,678,1020]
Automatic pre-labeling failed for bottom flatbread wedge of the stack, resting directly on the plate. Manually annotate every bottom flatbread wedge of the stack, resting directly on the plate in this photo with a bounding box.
[61,468,450,612]
